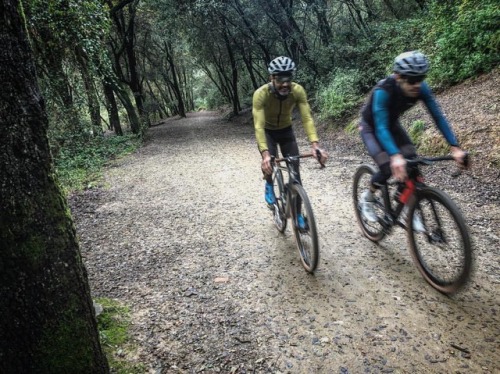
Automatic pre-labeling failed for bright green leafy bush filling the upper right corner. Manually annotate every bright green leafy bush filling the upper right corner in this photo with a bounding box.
[423,0,500,85]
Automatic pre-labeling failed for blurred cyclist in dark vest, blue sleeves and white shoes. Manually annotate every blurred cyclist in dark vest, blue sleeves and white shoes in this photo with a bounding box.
[360,51,465,225]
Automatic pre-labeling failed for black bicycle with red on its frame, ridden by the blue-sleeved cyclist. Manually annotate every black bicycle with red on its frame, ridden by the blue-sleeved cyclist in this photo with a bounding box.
[353,156,473,294]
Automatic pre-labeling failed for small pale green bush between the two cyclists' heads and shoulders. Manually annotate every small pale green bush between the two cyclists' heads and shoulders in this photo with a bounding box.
[316,69,362,119]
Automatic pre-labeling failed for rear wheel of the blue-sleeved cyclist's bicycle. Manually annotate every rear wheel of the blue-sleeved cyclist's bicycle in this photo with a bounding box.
[352,165,387,242]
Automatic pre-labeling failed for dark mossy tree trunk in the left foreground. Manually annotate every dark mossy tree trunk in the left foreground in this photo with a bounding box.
[0,0,109,374]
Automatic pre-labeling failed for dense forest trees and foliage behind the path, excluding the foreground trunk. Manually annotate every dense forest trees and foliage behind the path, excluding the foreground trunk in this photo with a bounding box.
[22,0,500,191]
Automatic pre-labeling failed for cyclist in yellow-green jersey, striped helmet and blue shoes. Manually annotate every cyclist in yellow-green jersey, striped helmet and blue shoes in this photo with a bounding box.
[252,56,328,225]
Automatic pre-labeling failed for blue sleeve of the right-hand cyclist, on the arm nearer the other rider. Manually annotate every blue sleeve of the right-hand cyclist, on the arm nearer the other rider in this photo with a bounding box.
[372,89,400,156]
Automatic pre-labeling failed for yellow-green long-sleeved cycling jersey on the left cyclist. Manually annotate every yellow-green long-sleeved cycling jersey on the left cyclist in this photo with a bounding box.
[252,82,318,153]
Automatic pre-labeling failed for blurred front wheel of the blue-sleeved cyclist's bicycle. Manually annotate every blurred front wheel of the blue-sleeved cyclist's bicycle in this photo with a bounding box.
[407,186,473,294]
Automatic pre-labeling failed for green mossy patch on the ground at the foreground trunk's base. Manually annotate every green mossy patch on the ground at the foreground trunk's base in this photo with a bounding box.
[96,298,147,374]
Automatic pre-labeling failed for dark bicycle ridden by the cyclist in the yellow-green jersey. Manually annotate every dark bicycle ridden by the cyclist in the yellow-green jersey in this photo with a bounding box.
[271,153,324,273]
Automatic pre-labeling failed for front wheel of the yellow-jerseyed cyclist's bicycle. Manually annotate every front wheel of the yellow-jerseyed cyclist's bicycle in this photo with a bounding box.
[290,184,319,273]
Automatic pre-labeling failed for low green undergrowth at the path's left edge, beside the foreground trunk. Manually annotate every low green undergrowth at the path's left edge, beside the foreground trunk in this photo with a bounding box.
[55,134,140,193]
